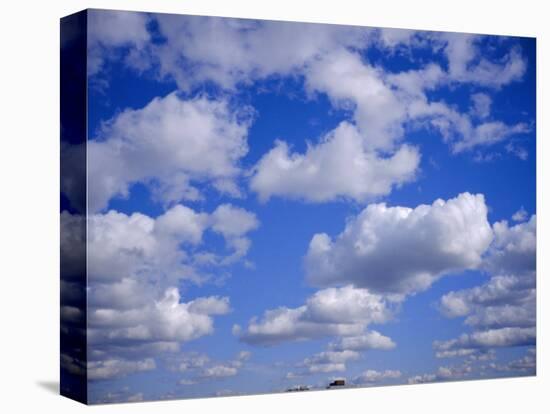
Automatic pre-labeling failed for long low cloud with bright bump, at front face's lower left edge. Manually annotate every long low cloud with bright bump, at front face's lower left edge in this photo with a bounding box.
[88,288,230,348]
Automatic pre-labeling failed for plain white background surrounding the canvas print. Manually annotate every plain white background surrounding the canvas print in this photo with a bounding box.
[0,0,550,413]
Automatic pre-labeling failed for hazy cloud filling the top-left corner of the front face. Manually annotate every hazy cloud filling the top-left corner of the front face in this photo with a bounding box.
[88,10,151,76]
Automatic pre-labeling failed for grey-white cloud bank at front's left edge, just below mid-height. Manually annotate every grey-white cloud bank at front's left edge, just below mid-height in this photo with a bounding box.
[88,206,206,286]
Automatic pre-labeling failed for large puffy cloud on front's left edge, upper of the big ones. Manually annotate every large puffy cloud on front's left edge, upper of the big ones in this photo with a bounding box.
[88,93,250,212]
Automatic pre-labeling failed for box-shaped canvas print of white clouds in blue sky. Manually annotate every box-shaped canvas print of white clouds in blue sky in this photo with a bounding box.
[60,10,536,404]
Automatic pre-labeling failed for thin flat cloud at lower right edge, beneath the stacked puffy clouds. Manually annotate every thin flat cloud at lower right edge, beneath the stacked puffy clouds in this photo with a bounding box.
[434,327,537,351]
